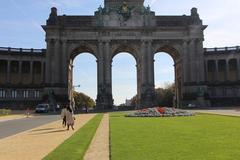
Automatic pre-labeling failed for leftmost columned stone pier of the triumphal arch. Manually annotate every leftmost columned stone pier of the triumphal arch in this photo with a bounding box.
[43,39,68,106]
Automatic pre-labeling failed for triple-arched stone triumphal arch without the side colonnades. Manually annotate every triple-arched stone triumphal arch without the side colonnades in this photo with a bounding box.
[43,0,206,108]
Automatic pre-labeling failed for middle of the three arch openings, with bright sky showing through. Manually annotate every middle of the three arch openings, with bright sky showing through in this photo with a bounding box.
[112,52,137,107]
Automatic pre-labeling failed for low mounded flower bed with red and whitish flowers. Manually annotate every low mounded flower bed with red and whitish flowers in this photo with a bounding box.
[126,107,195,117]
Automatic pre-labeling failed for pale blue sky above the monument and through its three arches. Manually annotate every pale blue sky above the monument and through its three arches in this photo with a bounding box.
[0,0,240,104]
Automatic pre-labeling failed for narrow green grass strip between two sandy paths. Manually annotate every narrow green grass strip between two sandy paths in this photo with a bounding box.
[44,114,103,160]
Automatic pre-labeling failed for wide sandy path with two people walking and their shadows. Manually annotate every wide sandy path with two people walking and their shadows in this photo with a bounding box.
[0,114,95,160]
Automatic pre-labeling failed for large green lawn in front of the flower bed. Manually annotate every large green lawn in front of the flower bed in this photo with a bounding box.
[110,113,240,160]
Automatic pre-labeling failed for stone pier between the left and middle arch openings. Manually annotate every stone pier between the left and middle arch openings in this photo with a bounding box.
[96,41,113,109]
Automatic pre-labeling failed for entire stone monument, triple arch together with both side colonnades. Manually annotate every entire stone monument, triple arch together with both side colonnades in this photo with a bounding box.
[0,0,240,109]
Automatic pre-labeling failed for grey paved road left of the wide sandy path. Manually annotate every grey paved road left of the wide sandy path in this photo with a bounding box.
[0,115,60,139]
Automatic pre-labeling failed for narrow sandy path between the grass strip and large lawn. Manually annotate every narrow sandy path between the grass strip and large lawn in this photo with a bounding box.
[84,114,109,160]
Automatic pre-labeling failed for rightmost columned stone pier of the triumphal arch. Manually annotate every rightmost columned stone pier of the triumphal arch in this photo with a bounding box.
[183,38,210,107]
